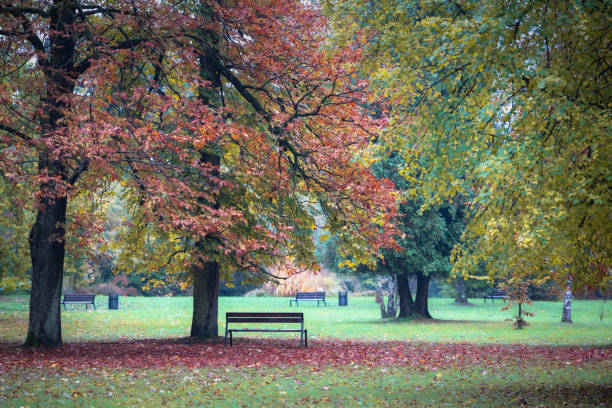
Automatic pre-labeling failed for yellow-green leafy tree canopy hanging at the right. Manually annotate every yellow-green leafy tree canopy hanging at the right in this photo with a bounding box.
[326,0,612,302]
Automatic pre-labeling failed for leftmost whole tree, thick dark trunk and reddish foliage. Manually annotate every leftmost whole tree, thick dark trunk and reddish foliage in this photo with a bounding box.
[0,0,207,346]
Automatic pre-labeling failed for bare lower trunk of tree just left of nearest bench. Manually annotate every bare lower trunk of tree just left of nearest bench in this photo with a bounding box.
[191,262,219,339]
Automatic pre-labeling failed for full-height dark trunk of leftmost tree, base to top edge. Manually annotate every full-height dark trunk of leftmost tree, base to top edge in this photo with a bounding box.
[24,0,80,347]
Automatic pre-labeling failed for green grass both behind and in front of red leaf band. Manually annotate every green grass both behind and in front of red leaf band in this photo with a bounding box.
[0,296,612,407]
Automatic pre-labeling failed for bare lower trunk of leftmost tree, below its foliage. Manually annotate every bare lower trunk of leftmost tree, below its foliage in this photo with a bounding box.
[24,197,67,347]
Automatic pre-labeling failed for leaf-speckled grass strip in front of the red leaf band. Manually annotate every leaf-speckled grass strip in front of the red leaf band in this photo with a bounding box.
[0,364,612,407]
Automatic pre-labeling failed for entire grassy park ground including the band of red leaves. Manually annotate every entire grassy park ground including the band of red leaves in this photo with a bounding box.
[0,296,612,407]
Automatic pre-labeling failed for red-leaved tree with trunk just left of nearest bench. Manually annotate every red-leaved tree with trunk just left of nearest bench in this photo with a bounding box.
[97,1,396,338]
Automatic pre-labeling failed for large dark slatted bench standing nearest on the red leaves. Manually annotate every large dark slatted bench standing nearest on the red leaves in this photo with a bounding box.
[223,312,308,347]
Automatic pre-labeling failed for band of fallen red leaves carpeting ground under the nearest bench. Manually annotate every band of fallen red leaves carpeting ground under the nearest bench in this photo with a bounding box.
[0,338,612,372]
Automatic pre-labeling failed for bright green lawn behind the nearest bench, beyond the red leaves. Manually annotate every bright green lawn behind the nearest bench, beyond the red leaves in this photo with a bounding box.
[0,296,612,345]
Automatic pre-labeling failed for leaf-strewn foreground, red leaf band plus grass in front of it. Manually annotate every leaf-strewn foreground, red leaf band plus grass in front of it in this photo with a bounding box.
[0,339,612,407]
